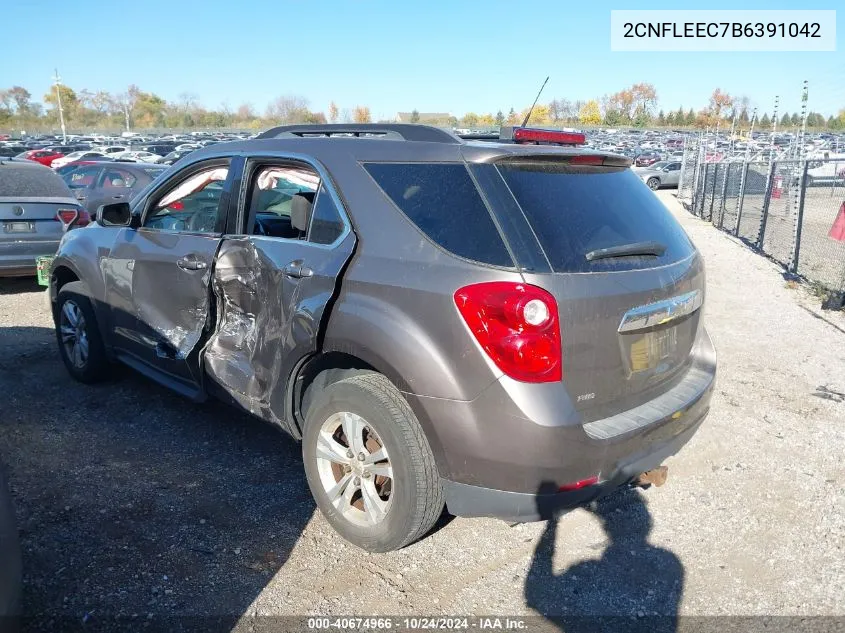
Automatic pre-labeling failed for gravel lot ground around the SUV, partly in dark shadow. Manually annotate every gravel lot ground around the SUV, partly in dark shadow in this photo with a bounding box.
[0,192,845,630]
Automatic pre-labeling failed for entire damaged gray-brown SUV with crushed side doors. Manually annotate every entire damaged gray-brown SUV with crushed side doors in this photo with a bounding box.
[50,124,716,551]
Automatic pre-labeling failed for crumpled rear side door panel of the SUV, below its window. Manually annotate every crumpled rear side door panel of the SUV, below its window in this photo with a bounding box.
[203,232,355,428]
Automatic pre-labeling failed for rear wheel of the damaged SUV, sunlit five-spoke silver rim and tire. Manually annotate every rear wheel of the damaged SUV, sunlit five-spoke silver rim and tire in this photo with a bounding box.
[302,372,444,552]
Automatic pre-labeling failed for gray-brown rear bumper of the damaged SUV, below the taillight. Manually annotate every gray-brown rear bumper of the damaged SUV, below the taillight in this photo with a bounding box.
[407,328,716,520]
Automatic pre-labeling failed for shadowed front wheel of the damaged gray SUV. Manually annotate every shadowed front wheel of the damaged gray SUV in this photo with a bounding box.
[56,281,109,383]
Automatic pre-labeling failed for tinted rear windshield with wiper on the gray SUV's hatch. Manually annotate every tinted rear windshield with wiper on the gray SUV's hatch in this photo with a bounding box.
[498,161,693,272]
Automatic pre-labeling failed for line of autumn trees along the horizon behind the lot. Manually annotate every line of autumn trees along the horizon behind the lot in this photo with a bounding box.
[0,83,845,132]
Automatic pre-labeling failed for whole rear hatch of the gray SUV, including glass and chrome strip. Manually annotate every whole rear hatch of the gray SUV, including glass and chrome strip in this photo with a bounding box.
[496,156,704,421]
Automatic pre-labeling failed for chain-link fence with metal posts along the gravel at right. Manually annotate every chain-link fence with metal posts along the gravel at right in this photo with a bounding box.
[678,151,845,304]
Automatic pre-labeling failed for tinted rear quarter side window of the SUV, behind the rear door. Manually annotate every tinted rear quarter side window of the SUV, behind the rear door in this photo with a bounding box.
[364,163,513,267]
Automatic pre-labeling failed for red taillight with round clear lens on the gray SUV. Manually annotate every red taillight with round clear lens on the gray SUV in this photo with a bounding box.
[455,281,563,382]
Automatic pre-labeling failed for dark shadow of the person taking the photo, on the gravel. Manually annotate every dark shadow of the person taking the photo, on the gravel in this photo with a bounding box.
[525,487,684,633]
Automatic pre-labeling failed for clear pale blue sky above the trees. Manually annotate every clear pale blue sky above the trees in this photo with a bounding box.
[0,0,845,119]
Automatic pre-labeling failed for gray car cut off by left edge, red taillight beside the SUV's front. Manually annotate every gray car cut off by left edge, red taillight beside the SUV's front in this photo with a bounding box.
[0,159,90,277]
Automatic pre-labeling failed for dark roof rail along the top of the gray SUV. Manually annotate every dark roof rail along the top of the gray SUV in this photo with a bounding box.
[255,123,461,144]
